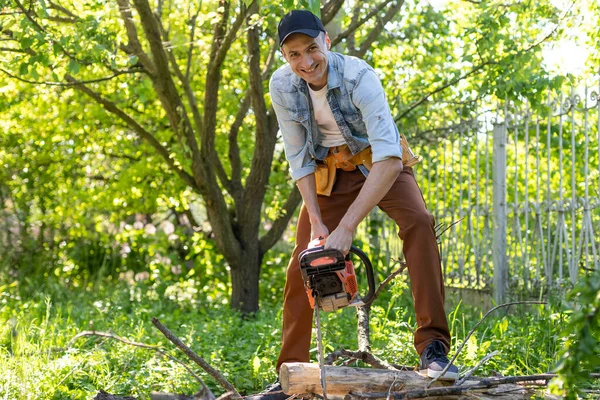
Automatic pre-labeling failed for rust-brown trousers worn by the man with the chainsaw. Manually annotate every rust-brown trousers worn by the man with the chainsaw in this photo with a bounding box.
[277,167,450,371]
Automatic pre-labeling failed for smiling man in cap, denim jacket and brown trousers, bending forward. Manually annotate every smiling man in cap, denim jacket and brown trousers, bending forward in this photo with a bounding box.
[263,10,458,399]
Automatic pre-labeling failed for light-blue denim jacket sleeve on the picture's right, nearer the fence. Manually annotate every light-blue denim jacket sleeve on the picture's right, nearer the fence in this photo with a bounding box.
[352,68,402,162]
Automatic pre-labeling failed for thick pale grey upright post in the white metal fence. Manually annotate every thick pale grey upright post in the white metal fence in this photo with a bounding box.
[492,122,508,304]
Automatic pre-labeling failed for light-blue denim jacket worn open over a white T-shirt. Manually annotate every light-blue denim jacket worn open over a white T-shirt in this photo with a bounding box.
[269,52,402,180]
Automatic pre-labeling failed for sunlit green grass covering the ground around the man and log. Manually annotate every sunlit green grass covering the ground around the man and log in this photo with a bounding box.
[0,271,565,399]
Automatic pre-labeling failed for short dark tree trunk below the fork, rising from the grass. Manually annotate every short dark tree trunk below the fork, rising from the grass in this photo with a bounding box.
[230,245,262,314]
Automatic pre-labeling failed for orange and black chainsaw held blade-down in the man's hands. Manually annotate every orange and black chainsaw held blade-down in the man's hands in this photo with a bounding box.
[299,238,375,398]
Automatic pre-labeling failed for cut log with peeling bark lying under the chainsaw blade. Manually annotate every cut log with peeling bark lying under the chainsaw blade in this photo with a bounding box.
[279,363,444,396]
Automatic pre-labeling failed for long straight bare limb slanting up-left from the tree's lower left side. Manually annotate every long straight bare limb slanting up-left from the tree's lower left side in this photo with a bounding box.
[65,75,198,194]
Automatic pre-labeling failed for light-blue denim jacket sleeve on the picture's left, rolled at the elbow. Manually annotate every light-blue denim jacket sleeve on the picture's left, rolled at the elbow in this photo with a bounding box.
[269,78,317,181]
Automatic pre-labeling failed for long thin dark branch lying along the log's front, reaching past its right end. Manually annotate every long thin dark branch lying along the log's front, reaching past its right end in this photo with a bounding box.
[344,374,556,400]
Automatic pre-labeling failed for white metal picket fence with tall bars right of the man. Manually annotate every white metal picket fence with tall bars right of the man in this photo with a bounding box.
[360,76,600,300]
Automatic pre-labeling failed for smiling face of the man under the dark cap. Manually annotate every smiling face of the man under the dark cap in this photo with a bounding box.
[281,33,331,90]
